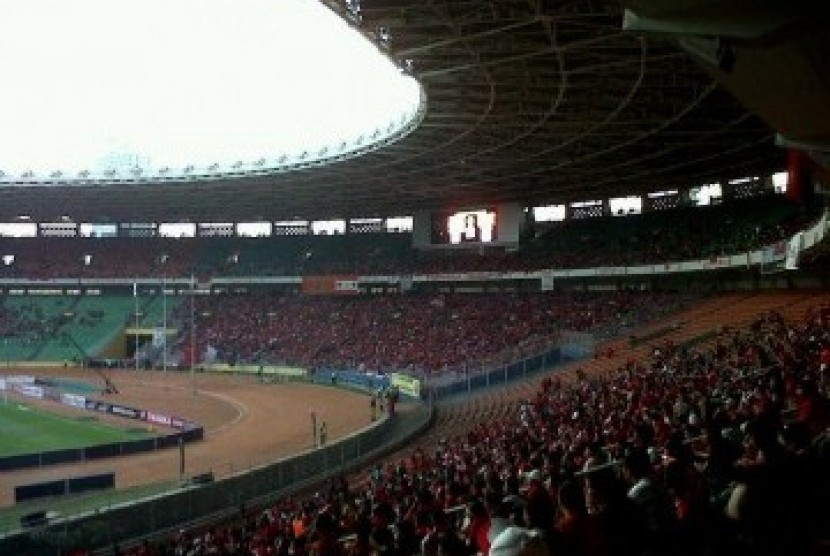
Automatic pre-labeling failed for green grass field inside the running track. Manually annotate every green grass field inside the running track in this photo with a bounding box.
[0,400,150,456]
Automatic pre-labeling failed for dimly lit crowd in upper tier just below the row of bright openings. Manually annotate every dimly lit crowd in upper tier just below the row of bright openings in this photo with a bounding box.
[0,196,818,279]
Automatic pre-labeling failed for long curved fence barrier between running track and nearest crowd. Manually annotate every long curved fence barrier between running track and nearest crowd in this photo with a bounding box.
[0,405,432,556]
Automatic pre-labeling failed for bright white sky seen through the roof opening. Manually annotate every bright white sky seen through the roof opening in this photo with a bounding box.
[0,0,423,182]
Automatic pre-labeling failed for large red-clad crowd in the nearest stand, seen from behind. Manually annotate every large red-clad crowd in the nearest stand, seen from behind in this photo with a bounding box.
[122,300,830,556]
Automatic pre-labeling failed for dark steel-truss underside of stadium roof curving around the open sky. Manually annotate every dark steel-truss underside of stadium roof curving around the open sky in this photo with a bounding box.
[0,0,824,222]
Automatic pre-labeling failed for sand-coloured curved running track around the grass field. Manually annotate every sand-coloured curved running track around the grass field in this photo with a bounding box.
[0,369,369,506]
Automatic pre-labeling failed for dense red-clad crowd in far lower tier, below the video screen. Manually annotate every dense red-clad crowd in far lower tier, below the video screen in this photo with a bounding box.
[196,291,677,373]
